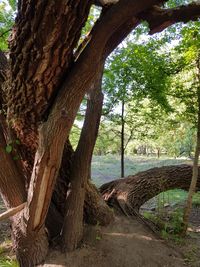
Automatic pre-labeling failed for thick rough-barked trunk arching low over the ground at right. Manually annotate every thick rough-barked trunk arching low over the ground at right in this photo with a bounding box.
[100,164,200,215]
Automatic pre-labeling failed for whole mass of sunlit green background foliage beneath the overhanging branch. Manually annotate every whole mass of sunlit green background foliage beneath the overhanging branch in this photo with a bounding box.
[95,21,200,157]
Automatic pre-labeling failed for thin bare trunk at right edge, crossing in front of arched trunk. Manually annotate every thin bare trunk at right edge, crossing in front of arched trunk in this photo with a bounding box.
[182,55,200,235]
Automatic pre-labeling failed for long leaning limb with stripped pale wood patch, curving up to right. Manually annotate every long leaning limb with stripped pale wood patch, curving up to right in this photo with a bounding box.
[26,0,163,233]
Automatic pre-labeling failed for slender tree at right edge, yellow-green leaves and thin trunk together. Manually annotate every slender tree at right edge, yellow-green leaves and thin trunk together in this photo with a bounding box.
[171,22,200,234]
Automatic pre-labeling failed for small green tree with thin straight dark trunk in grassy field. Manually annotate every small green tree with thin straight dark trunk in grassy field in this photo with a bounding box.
[103,39,172,172]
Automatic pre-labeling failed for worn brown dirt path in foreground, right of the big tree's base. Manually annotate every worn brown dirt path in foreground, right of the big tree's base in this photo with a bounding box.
[40,217,187,267]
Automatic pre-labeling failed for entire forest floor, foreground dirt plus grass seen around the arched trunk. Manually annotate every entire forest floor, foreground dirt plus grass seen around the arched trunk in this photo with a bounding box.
[0,156,200,267]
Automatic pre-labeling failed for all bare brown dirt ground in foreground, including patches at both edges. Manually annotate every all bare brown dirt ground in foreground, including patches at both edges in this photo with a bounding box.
[0,200,200,267]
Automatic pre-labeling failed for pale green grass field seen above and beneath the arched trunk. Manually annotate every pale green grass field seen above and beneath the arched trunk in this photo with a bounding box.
[92,154,197,207]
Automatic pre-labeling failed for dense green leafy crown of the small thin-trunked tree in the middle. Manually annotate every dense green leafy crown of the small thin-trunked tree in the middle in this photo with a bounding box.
[103,39,172,108]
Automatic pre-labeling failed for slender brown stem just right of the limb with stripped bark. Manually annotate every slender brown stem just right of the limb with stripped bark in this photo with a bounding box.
[62,65,108,251]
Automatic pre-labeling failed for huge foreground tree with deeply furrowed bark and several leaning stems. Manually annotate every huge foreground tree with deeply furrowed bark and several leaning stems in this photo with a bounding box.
[0,0,200,267]
